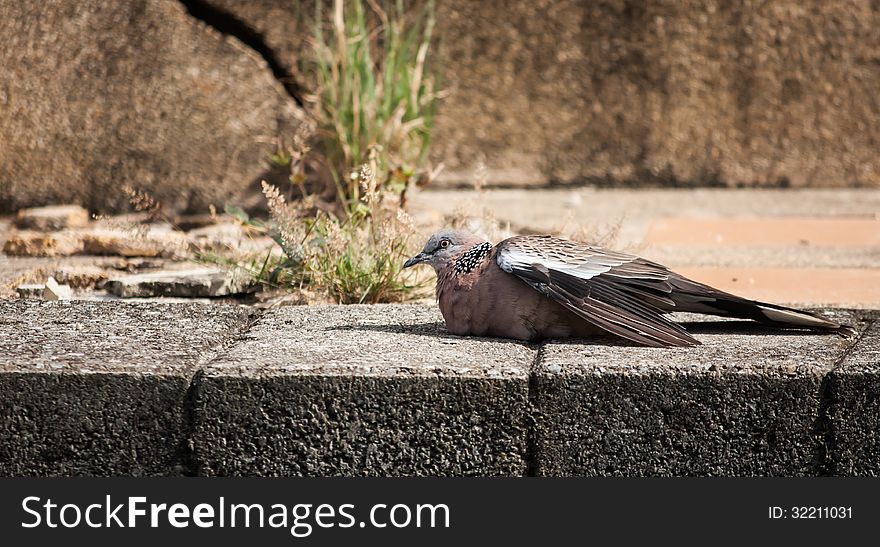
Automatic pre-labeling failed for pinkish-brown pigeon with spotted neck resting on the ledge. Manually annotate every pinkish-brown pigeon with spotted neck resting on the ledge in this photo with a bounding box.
[403,229,853,347]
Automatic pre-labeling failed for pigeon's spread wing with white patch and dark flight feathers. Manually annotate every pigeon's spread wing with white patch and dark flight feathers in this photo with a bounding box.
[495,236,699,347]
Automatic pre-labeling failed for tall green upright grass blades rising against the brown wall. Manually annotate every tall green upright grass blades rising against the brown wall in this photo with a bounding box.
[302,0,438,214]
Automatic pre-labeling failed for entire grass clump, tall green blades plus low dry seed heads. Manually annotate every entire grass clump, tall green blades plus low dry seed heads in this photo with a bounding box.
[203,0,439,304]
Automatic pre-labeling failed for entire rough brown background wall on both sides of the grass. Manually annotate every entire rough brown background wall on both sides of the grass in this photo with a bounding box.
[0,0,880,214]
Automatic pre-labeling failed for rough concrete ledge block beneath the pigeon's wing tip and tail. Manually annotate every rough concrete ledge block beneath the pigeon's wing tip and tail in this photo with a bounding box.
[532,315,868,476]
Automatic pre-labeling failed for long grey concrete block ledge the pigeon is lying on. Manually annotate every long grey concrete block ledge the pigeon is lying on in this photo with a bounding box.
[0,301,880,476]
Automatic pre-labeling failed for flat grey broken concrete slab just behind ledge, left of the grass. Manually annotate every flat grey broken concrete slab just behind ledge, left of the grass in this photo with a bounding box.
[104,268,250,298]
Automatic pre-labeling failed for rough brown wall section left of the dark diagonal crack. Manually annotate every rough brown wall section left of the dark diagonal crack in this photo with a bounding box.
[0,0,301,212]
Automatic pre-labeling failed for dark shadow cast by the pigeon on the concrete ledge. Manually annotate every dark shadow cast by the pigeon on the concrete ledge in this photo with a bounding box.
[326,321,815,347]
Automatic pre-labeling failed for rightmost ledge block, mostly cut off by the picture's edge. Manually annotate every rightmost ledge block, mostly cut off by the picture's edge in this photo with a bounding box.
[830,315,880,477]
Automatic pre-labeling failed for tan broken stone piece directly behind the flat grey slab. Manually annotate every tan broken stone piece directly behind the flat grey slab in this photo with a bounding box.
[82,227,187,257]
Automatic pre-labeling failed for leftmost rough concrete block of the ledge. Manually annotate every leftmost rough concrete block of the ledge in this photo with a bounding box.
[0,300,249,476]
